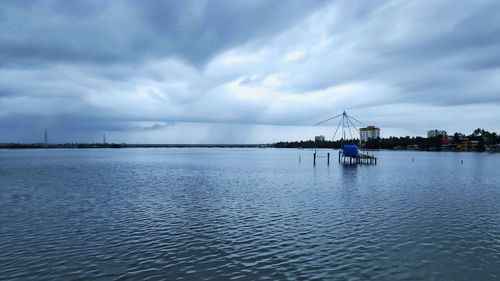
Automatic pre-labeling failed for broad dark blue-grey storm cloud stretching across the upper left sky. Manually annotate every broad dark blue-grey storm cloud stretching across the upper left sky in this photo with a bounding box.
[0,0,325,65]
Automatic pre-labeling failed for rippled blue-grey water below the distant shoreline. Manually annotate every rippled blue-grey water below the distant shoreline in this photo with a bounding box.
[0,148,500,280]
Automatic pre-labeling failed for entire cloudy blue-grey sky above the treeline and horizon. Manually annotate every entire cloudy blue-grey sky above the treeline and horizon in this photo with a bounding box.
[0,0,500,143]
